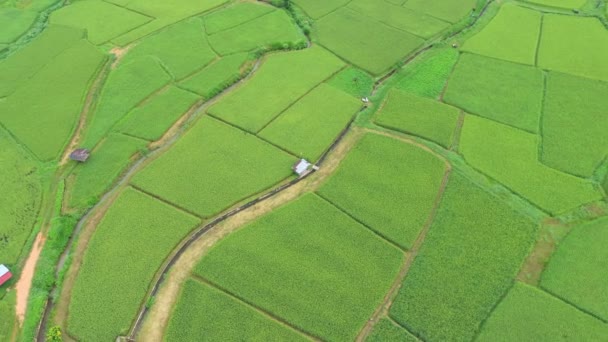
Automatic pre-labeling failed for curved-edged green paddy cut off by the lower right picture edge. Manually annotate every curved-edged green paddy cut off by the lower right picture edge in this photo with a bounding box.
[541,218,608,320]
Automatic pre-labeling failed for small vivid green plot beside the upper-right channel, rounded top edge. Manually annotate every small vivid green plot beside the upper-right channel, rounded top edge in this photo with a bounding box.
[395,47,459,99]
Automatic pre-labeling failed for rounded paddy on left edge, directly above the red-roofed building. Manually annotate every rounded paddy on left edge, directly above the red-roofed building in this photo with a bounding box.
[0,129,42,266]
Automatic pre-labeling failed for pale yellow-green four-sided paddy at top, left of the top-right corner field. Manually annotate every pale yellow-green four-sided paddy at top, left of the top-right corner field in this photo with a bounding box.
[462,4,542,65]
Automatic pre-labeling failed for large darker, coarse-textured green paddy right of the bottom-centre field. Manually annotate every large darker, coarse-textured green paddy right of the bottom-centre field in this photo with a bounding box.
[390,172,536,341]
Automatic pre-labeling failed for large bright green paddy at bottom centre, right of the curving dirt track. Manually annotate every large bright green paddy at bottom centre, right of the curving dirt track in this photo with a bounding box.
[195,194,403,341]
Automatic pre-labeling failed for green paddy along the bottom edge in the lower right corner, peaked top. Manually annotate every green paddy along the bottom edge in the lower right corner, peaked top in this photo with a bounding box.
[477,283,608,342]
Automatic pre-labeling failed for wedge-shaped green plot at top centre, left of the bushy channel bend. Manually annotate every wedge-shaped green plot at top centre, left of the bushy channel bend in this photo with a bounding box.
[209,10,306,55]
